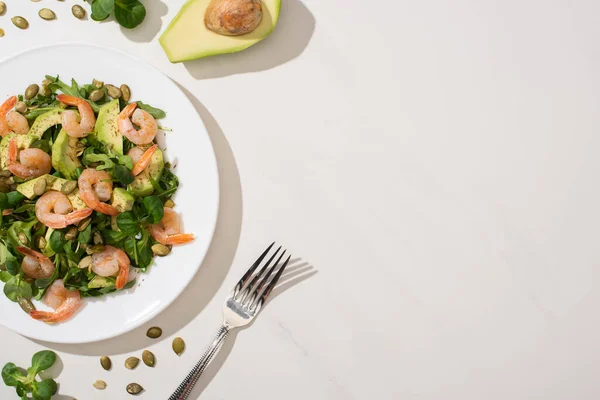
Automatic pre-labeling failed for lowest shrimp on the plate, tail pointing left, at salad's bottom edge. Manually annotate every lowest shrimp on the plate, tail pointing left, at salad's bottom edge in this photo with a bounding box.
[29,279,83,323]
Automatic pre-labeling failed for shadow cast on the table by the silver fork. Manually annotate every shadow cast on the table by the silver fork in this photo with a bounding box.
[190,258,317,399]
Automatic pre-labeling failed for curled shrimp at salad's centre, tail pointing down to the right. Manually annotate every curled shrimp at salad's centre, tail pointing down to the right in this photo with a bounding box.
[79,168,119,215]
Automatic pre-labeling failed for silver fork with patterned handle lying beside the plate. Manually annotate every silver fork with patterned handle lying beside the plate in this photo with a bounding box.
[169,242,291,400]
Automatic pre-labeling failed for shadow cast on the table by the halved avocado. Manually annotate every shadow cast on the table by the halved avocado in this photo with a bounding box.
[183,0,316,79]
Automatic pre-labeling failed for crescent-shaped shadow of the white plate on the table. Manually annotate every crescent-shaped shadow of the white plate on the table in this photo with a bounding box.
[34,83,242,356]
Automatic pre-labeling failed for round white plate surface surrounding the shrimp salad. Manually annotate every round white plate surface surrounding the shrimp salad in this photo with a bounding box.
[0,44,219,343]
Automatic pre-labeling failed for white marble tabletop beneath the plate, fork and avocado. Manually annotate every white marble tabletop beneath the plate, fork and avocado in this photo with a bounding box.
[0,0,600,400]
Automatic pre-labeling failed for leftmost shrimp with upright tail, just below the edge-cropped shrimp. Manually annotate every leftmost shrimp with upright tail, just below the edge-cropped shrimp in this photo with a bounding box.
[7,137,52,179]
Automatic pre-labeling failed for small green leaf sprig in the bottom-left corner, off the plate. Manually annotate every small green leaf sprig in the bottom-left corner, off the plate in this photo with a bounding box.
[2,350,58,400]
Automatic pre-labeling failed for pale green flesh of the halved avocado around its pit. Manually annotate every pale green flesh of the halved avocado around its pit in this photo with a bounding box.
[158,0,281,63]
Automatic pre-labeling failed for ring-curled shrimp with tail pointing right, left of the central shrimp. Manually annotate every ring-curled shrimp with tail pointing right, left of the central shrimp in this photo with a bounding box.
[35,190,93,229]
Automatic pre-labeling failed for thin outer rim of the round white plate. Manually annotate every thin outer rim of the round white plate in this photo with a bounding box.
[0,41,221,344]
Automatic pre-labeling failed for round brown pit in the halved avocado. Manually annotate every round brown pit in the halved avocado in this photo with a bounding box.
[204,0,263,36]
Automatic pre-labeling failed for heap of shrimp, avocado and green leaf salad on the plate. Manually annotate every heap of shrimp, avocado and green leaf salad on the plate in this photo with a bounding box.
[0,76,193,323]
